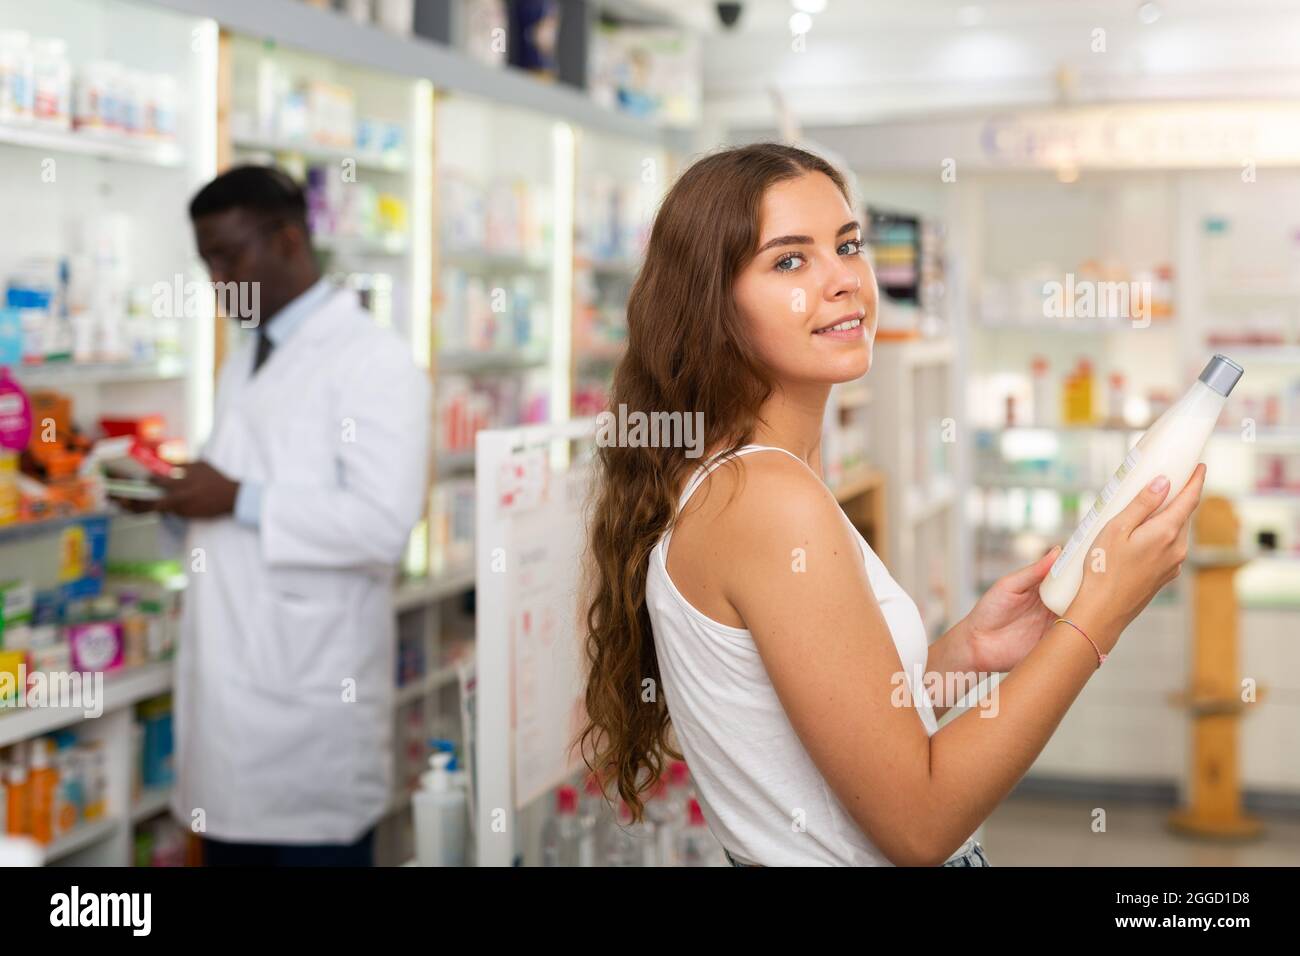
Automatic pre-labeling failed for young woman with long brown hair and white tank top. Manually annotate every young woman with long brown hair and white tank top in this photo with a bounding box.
[581,144,1204,866]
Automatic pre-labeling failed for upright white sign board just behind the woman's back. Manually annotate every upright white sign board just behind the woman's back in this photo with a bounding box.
[475,419,595,866]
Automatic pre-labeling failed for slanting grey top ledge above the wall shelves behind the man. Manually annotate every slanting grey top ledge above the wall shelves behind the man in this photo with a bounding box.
[152,0,677,144]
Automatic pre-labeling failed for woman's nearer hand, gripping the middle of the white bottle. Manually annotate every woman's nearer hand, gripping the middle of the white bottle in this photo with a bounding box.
[1065,464,1205,650]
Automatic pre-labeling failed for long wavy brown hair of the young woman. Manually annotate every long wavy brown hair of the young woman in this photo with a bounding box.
[577,143,853,819]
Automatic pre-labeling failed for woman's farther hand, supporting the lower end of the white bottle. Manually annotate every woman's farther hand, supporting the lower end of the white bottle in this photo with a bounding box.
[965,546,1061,672]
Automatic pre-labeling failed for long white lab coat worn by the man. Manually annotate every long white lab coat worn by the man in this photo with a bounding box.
[172,291,432,844]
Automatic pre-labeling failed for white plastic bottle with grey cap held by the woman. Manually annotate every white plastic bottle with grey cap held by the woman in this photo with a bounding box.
[1039,355,1243,614]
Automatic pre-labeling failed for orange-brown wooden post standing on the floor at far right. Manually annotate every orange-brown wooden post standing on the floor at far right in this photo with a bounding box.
[1169,496,1264,839]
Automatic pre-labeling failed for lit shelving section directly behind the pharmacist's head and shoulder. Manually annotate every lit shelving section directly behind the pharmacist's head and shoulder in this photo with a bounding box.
[218,33,433,365]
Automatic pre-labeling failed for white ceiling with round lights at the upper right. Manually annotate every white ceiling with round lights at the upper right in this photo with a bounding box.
[639,0,1300,137]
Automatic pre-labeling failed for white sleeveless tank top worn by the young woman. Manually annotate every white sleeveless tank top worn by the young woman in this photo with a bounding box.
[646,445,974,866]
